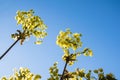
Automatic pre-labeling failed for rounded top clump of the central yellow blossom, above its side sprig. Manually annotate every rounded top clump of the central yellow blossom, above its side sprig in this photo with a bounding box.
[56,29,82,50]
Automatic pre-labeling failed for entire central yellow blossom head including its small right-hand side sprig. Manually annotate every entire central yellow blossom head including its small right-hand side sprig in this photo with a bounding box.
[56,29,93,65]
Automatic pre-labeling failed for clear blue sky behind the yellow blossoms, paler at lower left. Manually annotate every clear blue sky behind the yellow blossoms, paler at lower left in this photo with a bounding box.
[0,0,120,80]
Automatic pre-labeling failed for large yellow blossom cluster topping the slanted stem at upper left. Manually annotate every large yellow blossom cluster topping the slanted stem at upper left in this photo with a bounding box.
[12,10,47,44]
